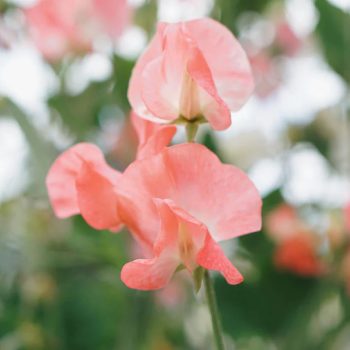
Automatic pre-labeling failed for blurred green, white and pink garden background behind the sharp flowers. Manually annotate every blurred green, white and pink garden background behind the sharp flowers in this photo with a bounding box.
[0,0,350,350]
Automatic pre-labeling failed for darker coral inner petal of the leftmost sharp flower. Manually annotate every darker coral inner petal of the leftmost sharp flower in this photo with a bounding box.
[76,162,121,231]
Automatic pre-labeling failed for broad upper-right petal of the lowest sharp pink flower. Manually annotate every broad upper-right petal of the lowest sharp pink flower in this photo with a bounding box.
[161,144,262,241]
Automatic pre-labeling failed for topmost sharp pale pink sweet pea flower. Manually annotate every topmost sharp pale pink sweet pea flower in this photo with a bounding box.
[128,18,254,130]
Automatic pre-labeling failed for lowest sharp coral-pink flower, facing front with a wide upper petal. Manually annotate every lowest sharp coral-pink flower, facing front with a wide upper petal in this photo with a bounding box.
[117,144,261,290]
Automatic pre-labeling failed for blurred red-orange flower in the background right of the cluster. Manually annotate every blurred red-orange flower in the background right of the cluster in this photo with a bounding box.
[266,204,327,276]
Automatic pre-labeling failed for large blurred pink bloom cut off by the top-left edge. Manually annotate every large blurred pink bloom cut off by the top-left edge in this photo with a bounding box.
[25,0,130,60]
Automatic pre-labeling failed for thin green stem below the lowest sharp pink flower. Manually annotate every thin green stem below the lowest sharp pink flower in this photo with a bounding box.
[204,270,225,350]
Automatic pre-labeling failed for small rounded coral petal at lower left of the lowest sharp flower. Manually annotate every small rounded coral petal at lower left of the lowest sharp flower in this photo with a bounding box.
[121,256,177,290]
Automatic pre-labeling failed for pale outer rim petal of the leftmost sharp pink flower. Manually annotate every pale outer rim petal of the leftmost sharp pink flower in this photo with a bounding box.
[46,143,119,218]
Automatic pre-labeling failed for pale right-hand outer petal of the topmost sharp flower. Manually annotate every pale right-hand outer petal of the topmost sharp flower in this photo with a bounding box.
[183,18,254,111]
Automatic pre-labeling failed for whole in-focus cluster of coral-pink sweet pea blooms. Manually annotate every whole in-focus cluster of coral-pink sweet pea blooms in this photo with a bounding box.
[47,19,261,290]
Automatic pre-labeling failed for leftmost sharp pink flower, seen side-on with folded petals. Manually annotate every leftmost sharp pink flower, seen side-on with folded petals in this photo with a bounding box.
[46,143,121,230]
